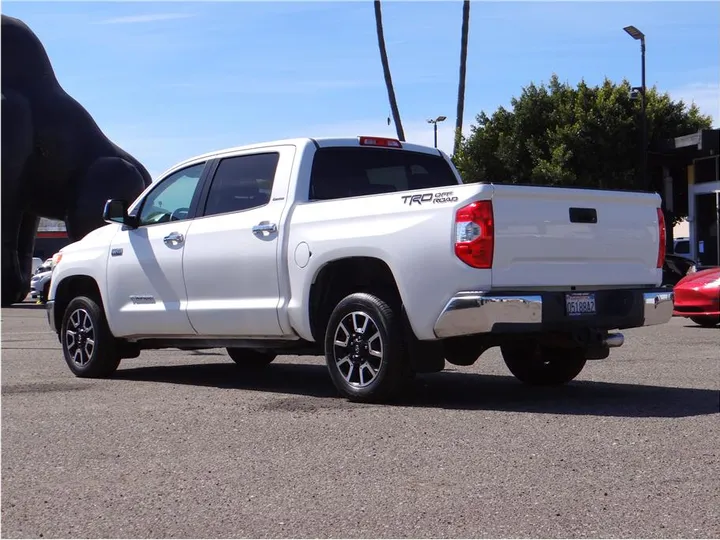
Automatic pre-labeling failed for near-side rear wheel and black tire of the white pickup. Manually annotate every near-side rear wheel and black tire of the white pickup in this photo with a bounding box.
[325,293,413,403]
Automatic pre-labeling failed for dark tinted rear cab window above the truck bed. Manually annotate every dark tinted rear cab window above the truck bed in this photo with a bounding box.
[309,147,458,200]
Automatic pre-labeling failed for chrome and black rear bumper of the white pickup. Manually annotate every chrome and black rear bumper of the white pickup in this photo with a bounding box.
[434,288,674,338]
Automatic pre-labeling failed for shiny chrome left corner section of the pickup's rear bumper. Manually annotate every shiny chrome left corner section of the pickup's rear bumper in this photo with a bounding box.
[434,291,542,338]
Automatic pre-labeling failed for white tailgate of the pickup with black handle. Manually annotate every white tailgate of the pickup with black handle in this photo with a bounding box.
[492,185,662,289]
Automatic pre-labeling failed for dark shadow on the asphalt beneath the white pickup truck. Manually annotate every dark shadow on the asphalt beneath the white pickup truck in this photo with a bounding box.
[113,363,720,418]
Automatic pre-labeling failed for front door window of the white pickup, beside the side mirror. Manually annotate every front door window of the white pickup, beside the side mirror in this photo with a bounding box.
[139,163,205,225]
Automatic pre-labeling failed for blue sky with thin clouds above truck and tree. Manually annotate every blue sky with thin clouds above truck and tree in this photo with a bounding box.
[3,0,720,177]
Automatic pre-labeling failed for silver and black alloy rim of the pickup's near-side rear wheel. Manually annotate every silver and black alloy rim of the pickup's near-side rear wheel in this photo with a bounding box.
[333,311,383,388]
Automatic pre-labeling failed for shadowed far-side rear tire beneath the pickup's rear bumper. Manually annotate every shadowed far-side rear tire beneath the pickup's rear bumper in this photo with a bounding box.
[500,341,587,386]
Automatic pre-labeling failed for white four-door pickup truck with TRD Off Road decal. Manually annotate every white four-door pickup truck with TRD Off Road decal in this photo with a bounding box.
[47,137,673,401]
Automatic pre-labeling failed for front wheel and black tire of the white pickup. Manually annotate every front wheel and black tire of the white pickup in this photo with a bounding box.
[60,296,120,378]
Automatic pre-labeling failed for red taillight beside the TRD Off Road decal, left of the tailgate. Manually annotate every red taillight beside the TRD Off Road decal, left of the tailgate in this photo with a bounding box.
[455,201,495,268]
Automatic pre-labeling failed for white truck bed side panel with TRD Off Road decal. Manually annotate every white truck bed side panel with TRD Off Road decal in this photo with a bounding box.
[287,184,492,340]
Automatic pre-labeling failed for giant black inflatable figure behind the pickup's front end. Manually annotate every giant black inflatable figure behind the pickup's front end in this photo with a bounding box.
[1,15,151,306]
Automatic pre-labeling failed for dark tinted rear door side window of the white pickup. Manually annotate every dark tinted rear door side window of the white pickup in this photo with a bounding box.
[205,152,280,216]
